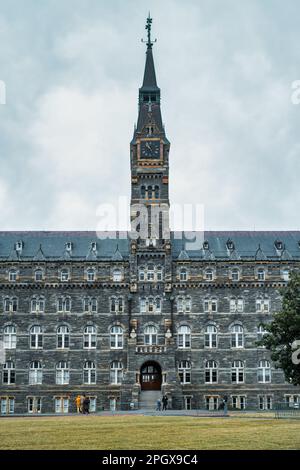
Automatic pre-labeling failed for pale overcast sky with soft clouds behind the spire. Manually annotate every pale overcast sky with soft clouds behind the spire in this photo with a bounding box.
[0,0,300,230]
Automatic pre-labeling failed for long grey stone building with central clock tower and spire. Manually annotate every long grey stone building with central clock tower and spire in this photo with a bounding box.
[0,18,300,414]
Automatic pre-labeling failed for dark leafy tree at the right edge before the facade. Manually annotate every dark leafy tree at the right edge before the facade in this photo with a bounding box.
[259,273,300,385]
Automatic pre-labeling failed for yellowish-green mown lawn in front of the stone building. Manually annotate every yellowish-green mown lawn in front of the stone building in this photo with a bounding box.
[0,415,300,450]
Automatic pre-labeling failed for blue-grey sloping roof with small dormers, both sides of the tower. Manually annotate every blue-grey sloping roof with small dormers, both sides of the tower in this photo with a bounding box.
[0,231,300,262]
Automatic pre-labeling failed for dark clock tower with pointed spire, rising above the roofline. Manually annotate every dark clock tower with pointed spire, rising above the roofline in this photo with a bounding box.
[130,15,170,242]
